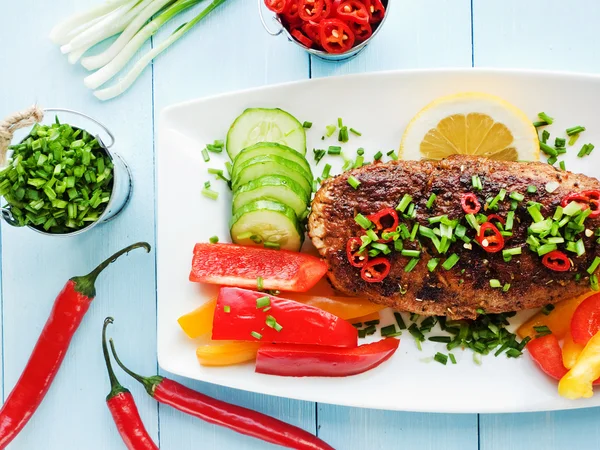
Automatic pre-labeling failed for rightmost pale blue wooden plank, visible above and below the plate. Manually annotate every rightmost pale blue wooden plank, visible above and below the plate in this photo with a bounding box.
[473,0,600,450]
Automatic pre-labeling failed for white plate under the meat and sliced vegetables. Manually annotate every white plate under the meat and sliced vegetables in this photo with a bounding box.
[157,69,600,413]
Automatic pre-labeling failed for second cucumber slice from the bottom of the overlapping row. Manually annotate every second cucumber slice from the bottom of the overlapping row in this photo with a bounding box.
[233,175,310,217]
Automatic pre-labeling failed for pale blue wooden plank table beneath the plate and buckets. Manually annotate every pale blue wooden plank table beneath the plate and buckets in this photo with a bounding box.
[0,0,600,450]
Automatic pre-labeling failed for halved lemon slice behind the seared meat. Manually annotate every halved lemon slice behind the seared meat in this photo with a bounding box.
[399,92,540,161]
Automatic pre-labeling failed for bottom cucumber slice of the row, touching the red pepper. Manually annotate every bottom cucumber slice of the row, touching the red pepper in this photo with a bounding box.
[230,200,304,251]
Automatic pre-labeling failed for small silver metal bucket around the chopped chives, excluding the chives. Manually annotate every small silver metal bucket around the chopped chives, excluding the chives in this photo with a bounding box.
[1,108,133,237]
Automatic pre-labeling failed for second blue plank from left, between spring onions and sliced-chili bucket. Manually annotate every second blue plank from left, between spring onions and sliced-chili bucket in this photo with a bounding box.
[154,0,316,449]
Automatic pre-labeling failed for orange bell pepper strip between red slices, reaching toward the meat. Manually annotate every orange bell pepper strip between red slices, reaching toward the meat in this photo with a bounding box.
[281,293,386,322]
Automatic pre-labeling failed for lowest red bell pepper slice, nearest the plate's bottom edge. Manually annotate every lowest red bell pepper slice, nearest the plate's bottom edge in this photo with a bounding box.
[256,338,400,377]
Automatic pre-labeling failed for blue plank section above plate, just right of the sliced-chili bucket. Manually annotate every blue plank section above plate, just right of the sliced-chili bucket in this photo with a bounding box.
[311,0,471,77]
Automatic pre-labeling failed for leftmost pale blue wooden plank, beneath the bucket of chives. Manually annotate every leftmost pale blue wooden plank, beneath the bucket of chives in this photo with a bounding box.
[0,0,158,449]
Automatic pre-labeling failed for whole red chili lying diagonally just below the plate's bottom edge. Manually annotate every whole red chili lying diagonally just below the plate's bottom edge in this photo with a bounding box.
[110,339,333,450]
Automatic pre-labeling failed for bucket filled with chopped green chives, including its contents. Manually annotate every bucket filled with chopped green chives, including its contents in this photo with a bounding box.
[0,107,132,236]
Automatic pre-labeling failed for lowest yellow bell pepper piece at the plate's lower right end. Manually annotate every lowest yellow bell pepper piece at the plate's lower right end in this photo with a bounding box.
[558,333,600,400]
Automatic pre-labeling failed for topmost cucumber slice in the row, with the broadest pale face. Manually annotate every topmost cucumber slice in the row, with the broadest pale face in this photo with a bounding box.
[226,108,306,161]
